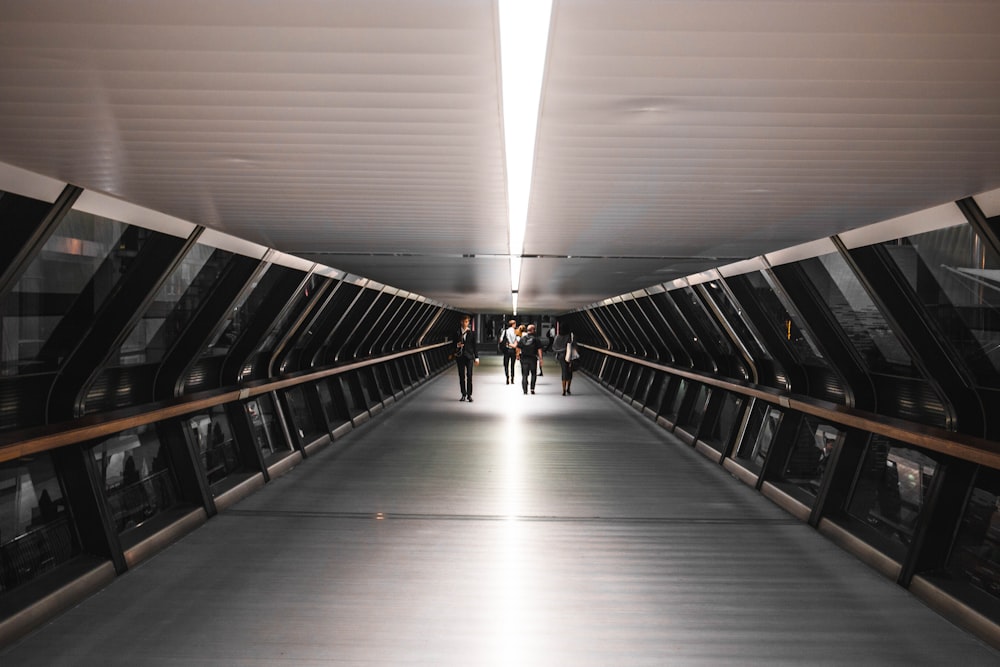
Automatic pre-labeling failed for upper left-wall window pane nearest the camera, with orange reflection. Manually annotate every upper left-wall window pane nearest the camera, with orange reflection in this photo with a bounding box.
[0,211,136,375]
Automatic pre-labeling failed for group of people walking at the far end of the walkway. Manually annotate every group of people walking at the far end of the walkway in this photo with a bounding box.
[453,317,578,403]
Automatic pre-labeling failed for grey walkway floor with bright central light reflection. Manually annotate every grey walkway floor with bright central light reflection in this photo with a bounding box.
[0,357,1000,667]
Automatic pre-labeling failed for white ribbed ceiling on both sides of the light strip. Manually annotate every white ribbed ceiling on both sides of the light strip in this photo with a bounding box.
[0,0,1000,312]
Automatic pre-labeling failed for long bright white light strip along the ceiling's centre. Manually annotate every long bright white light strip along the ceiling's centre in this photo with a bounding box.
[499,0,552,310]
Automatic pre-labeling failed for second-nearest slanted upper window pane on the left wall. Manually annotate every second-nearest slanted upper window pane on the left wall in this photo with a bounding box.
[118,245,233,366]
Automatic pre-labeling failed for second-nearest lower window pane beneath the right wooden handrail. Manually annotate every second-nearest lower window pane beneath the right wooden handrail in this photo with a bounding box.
[848,435,937,545]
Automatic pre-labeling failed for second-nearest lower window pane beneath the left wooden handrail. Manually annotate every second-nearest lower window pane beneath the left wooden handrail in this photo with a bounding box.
[93,425,178,533]
